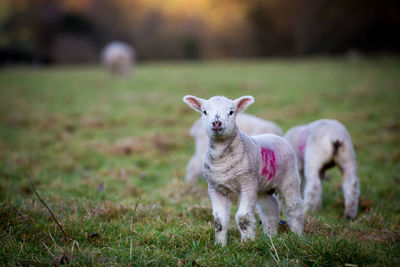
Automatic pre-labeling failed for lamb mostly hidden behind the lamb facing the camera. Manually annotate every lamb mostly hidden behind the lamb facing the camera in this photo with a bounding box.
[185,114,283,184]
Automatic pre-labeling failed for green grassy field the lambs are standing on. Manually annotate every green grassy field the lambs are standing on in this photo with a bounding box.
[0,57,400,266]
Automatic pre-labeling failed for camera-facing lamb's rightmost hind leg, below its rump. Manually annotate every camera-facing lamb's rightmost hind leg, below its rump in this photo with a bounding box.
[279,168,304,235]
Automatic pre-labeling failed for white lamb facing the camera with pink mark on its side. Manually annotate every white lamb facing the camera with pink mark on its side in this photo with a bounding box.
[183,95,304,246]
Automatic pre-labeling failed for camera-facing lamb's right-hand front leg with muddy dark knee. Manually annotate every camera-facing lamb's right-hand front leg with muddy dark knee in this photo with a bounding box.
[236,185,257,244]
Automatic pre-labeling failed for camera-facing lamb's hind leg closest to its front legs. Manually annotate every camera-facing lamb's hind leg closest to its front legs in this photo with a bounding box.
[257,194,279,236]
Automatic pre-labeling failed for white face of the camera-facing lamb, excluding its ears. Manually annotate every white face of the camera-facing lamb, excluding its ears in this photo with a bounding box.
[201,96,237,139]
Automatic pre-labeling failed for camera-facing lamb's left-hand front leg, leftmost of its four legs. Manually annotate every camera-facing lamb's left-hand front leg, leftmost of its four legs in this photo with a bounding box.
[208,185,232,246]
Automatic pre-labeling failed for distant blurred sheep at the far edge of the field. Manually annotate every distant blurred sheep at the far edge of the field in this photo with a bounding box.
[101,41,135,76]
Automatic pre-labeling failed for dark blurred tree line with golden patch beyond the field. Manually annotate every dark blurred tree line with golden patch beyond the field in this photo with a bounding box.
[0,0,400,64]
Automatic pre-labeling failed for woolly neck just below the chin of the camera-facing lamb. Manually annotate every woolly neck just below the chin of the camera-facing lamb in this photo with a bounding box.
[207,126,244,164]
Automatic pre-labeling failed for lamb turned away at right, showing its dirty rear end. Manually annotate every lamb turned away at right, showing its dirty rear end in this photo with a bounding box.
[284,119,360,219]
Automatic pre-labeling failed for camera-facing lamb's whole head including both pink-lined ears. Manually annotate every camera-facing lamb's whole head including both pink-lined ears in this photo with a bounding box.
[183,95,254,139]
